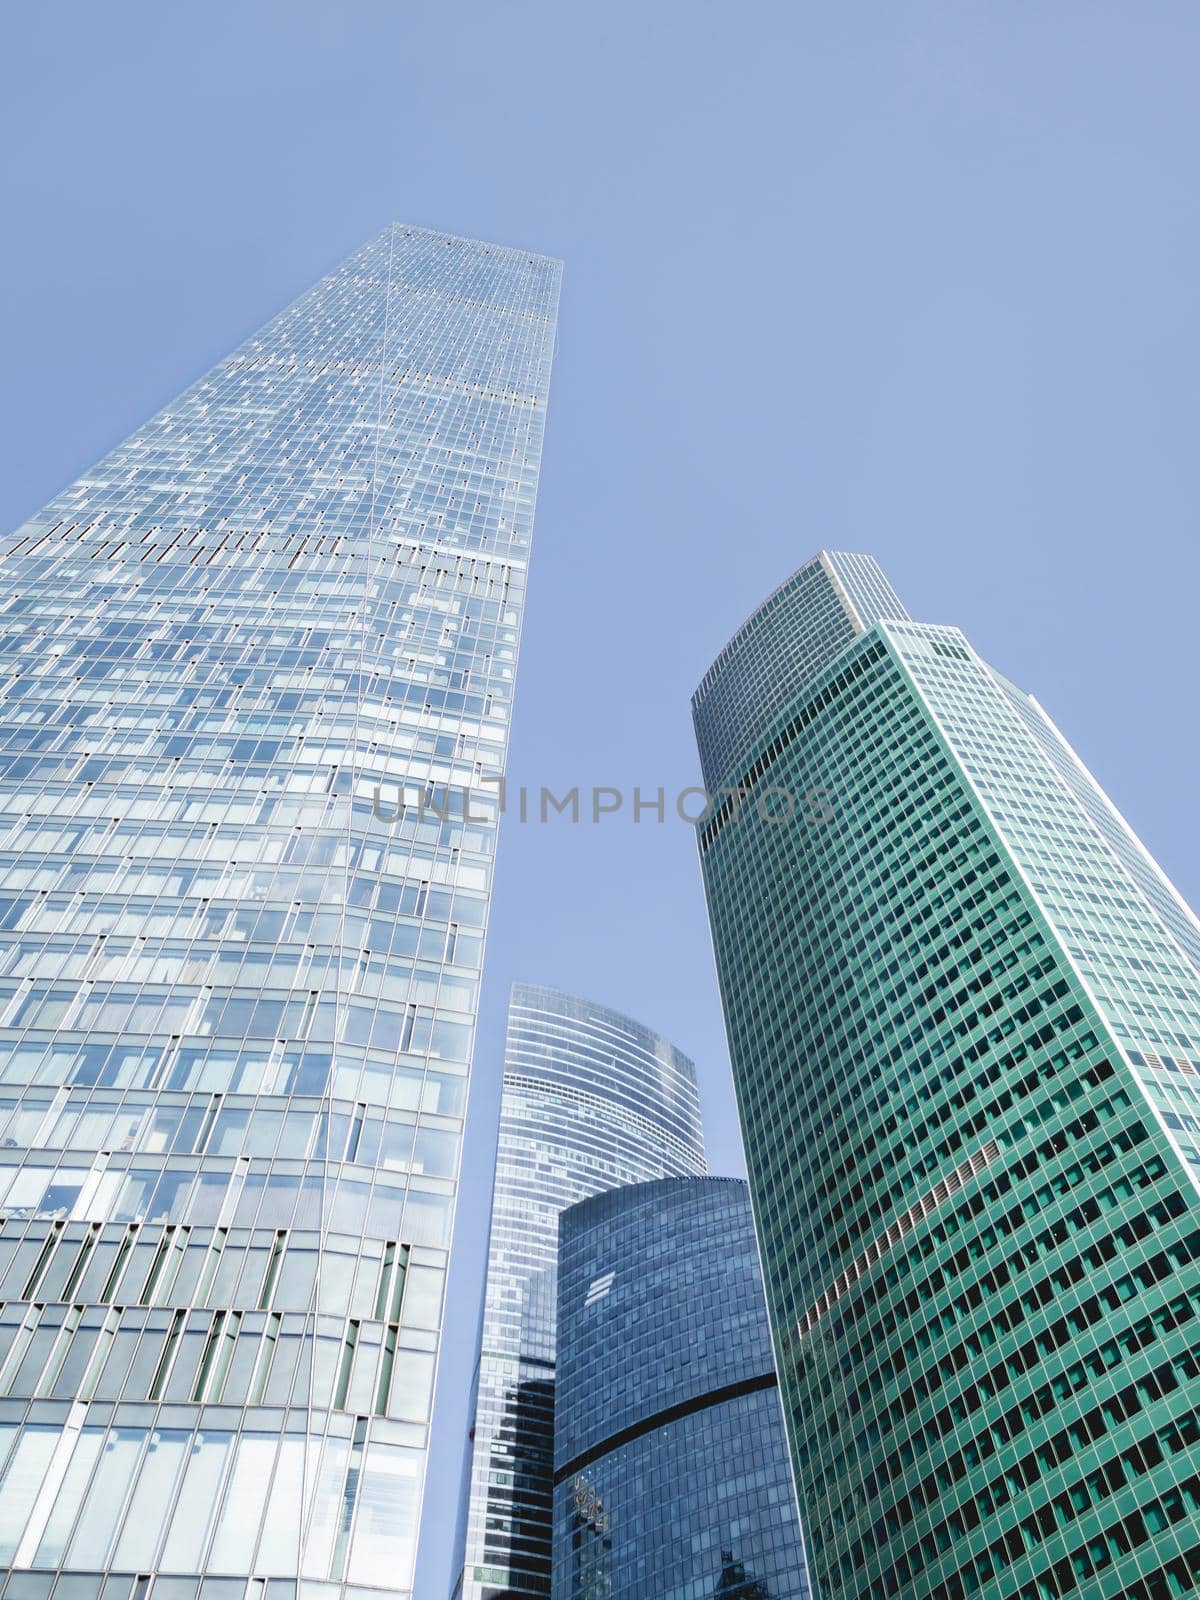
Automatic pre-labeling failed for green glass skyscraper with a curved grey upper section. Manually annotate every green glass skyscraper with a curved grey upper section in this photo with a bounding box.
[694,554,1200,1600]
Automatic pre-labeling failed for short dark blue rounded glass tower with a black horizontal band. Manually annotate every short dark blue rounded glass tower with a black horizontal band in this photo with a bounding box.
[554,1178,810,1600]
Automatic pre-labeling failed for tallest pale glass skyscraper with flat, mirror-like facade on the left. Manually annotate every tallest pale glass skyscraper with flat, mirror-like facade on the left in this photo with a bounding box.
[0,224,558,1600]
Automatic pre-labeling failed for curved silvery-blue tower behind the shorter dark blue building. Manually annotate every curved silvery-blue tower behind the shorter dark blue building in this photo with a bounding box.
[456,984,704,1600]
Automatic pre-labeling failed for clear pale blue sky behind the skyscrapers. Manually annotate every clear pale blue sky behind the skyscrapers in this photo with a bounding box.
[0,9,1200,1600]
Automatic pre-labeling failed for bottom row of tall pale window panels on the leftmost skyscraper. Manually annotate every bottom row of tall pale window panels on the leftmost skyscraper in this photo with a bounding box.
[0,1408,419,1589]
